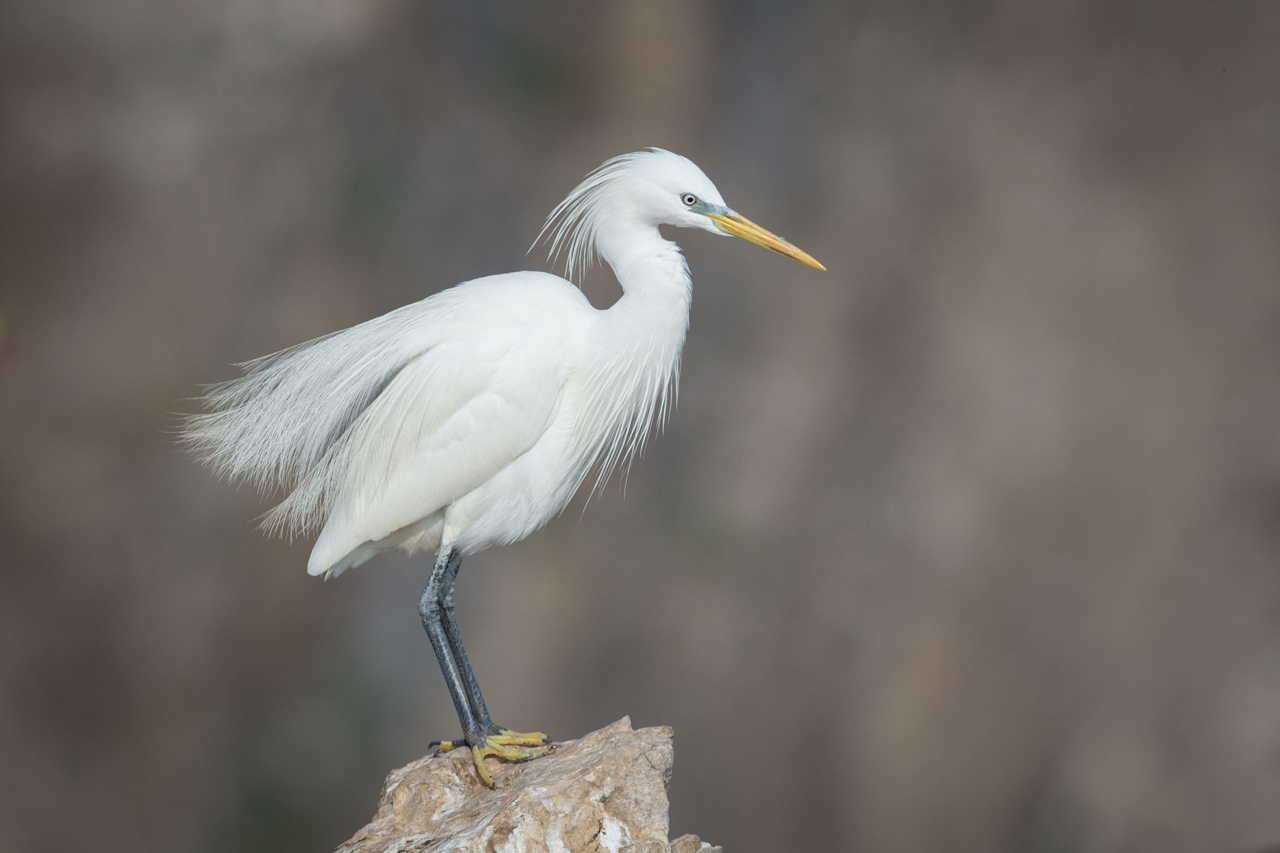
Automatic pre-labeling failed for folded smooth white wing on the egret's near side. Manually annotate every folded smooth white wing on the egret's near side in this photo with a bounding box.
[304,317,568,574]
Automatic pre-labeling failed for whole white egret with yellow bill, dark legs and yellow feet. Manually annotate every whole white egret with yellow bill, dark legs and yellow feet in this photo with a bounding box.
[184,149,824,788]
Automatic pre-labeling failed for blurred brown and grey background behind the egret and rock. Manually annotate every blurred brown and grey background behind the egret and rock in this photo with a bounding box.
[0,0,1280,853]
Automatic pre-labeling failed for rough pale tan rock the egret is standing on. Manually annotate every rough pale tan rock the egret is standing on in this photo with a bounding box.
[338,717,721,853]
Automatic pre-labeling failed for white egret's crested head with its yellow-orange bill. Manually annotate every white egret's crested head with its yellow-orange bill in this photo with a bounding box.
[539,149,826,278]
